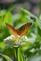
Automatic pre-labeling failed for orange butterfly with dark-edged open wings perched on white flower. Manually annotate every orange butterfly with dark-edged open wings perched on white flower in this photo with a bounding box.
[6,23,32,37]
